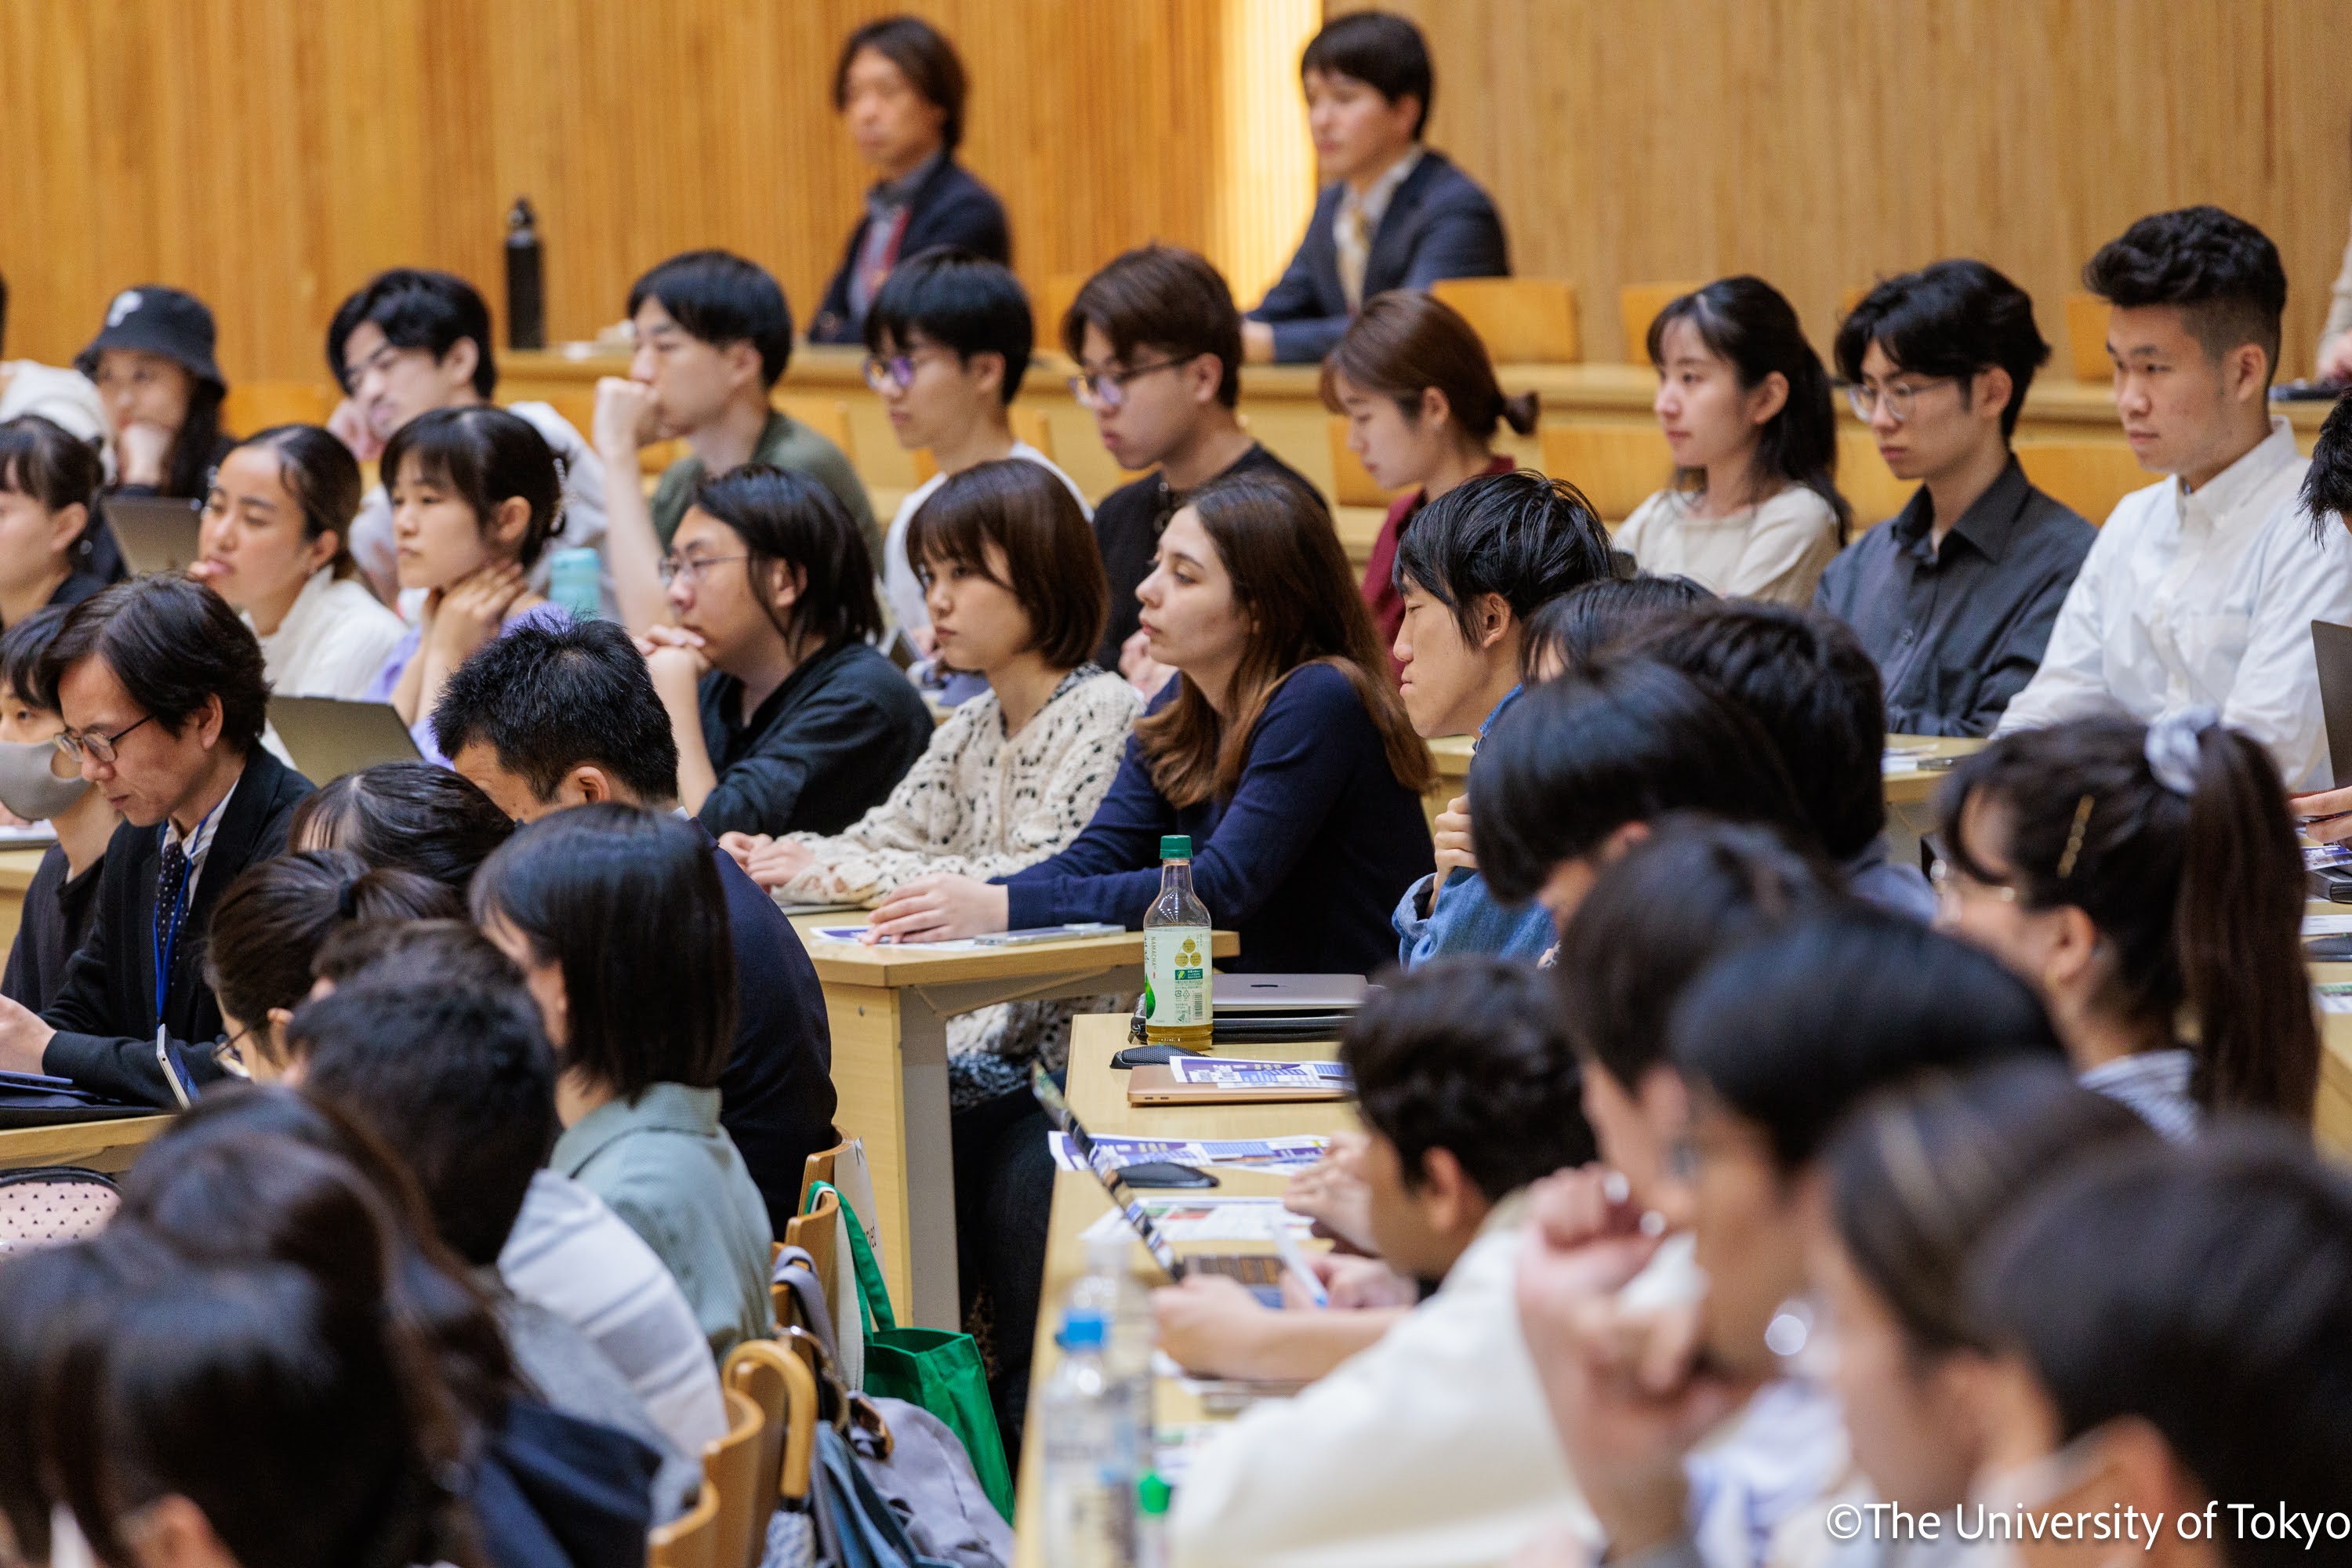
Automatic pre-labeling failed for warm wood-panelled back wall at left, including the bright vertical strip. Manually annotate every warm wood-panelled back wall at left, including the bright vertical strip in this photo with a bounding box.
[0,0,1322,381]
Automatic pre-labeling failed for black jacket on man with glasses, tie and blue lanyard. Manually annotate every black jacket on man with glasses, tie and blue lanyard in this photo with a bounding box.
[40,746,310,1107]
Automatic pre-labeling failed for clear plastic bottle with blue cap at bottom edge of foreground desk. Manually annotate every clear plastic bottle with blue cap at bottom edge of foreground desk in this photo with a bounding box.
[1040,1307,1136,1568]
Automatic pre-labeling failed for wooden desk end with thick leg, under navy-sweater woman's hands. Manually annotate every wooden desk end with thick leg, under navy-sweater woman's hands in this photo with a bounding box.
[793,914,1242,1328]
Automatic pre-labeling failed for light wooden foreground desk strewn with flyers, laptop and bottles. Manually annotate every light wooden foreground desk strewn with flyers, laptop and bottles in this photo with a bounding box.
[1014,1018,1355,1568]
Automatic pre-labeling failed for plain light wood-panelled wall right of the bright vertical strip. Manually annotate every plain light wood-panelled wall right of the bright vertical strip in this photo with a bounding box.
[1331,0,2352,374]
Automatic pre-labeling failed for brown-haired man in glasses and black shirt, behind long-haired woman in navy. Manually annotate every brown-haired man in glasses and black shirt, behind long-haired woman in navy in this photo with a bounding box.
[1061,245,1315,691]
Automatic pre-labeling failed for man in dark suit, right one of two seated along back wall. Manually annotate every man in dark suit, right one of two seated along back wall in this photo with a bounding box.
[1242,12,1510,365]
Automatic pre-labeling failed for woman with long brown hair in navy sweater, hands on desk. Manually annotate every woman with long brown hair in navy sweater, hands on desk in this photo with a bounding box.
[873,475,1435,973]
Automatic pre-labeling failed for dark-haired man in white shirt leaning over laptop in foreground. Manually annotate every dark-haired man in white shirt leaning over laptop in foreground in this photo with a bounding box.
[1171,959,1597,1568]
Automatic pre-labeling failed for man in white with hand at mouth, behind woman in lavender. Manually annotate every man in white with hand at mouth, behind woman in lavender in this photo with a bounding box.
[327,268,614,616]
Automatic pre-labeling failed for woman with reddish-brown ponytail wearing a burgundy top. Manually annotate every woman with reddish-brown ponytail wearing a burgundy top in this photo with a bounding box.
[1322,289,1536,673]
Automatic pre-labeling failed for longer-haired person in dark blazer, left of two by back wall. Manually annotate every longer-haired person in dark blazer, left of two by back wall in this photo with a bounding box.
[809,16,1014,343]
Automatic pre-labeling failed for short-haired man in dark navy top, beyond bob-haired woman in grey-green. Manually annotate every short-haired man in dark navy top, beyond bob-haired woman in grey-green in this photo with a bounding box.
[433,621,837,1236]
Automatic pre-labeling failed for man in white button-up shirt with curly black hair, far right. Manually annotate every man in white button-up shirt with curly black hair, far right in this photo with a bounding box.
[1994,207,2352,789]
